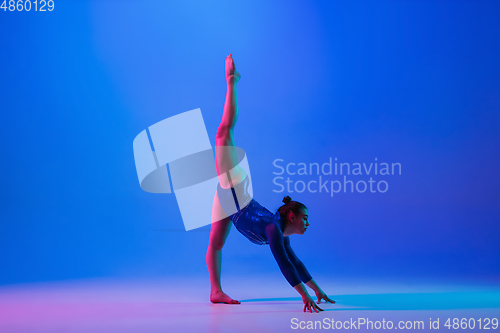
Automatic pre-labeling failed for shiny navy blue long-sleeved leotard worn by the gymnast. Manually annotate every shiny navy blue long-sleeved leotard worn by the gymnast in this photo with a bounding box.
[217,176,312,287]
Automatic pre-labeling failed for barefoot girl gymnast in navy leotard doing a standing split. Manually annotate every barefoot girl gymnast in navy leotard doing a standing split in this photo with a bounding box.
[206,54,335,312]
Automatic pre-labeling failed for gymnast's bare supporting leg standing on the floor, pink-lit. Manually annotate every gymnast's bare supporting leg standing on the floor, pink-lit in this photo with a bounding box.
[206,193,240,304]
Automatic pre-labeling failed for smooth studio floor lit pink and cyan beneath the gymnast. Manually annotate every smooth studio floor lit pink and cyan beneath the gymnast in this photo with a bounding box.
[0,277,500,333]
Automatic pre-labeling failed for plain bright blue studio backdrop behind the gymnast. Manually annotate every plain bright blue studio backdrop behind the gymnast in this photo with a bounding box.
[0,0,500,290]
